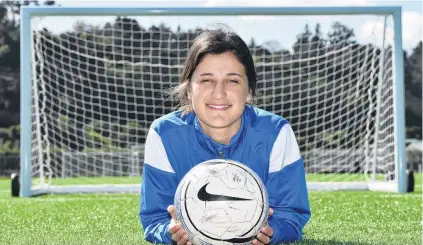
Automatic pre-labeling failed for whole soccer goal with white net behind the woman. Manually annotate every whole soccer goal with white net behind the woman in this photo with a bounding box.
[20,7,406,197]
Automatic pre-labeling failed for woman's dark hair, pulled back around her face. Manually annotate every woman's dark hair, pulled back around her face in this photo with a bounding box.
[171,29,257,113]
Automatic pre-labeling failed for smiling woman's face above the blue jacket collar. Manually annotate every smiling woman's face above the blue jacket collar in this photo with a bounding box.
[188,52,251,133]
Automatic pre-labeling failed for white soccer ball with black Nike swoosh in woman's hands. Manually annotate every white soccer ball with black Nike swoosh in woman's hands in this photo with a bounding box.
[174,159,269,245]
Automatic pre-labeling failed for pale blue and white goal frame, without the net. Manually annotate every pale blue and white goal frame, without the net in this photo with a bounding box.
[20,6,407,197]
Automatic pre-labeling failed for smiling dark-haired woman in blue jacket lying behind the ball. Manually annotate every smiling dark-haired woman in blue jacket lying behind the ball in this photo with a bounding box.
[139,27,310,245]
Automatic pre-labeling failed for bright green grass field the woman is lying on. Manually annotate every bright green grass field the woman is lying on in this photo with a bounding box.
[0,175,422,245]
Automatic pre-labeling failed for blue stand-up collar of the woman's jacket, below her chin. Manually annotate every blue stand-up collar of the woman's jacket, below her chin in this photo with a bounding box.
[194,107,247,158]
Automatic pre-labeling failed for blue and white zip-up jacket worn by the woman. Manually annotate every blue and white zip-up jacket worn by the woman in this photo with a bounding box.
[139,105,310,244]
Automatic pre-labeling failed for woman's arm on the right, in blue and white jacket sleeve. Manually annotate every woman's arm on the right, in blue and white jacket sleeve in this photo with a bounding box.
[266,123,311,244]
